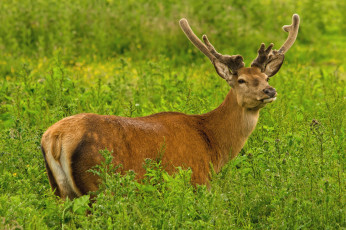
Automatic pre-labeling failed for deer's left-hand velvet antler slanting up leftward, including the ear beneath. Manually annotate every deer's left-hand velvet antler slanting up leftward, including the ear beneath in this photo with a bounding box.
[179,18,244,75]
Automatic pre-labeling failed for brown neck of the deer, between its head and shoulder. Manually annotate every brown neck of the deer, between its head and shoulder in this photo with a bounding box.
[202,89,259,172]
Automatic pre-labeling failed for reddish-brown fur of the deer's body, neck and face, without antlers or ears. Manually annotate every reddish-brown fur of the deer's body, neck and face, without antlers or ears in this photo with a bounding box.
[42,68,278,198]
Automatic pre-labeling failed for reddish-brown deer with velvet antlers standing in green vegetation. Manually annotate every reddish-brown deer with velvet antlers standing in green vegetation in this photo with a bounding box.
[41,14,300,199]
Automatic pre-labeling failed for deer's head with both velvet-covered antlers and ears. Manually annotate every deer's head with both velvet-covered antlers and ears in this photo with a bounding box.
[179,14,299,109]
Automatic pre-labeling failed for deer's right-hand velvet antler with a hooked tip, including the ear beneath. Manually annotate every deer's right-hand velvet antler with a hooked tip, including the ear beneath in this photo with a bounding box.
[251,14,299,77]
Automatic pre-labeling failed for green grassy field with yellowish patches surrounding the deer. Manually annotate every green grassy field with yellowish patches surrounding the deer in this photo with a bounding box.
[0,0,346,229]
